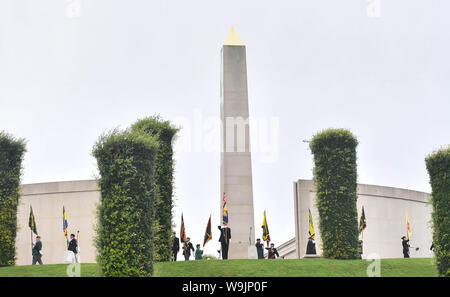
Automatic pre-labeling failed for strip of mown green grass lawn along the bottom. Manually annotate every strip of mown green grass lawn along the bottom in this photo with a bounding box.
[0,258,437,277]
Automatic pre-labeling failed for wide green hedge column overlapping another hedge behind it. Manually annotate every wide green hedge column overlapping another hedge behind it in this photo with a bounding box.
[93,131,157,276]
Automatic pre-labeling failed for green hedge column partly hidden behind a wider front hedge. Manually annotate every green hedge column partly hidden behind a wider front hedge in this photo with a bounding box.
[131,116,178,262]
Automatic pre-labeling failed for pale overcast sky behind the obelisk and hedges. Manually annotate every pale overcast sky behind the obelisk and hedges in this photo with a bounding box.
[0,0,450,255]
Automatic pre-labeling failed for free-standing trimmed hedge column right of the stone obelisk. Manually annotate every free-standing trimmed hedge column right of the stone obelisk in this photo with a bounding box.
[310,129,359,259]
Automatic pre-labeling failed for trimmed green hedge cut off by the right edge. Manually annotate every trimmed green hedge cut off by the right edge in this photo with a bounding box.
[425,146,450,277]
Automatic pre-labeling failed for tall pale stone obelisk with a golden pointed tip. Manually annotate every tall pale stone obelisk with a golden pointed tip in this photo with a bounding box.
[220,28,255,259]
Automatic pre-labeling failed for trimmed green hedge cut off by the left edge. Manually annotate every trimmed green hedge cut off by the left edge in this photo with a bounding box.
[0,131,26,266]
